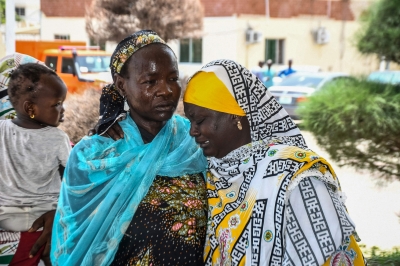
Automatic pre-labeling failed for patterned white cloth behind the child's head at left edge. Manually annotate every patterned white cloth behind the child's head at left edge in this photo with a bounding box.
[0,53,44,119]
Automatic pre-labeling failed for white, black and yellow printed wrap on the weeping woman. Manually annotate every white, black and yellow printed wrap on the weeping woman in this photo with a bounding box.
[194,60,364,266]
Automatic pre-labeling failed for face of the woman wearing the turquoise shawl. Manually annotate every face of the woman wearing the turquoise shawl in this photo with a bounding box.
[89,44,181,140]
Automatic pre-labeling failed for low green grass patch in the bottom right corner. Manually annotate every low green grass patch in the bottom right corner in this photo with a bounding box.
[363,247,400,266]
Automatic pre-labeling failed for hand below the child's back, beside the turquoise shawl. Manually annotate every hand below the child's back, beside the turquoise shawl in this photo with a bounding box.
[28,210,56,266]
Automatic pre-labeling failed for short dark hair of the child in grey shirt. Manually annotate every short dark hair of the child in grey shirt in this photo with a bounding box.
[8,63,61,107]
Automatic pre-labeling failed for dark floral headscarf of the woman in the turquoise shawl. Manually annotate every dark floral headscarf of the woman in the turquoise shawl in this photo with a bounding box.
[96,30,166,135]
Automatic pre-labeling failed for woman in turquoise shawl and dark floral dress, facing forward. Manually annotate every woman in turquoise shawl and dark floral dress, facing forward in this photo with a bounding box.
[51,30,207,265]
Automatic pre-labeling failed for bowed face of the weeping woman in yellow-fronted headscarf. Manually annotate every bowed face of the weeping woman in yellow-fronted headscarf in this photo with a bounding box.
[184,103,251,158]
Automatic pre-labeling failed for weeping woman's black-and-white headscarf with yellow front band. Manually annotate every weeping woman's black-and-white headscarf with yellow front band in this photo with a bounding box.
[183,60,307,148]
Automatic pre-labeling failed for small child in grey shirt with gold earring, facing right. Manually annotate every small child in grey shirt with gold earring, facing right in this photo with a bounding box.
[0,63,71,265]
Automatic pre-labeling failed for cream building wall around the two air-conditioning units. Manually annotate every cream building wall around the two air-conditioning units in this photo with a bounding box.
[177,15,379,78]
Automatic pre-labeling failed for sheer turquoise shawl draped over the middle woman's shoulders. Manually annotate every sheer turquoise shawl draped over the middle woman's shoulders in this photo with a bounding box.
[51,115,207,265]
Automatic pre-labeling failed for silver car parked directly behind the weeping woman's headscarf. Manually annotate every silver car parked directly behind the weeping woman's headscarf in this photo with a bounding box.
[268,72,351,119]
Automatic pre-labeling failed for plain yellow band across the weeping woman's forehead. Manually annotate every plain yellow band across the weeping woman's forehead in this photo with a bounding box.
[183,71,246,116]
